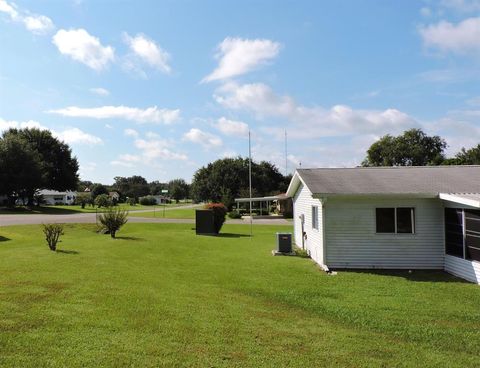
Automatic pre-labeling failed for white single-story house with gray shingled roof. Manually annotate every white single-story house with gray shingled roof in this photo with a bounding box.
[287,166,480,283]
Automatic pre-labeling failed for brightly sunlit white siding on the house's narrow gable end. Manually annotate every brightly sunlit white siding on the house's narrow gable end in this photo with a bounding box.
[293,184,324,265]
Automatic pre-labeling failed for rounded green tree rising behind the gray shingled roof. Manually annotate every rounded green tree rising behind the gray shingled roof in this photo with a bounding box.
[362,129,447,166]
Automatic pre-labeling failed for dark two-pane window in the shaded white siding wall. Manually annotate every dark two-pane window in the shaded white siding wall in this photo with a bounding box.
[376,207,415,234]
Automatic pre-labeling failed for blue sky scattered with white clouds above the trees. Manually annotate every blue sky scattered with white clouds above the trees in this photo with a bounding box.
[0,0,480,184]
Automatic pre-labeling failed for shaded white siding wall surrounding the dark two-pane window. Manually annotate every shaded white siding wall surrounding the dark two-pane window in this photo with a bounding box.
[325,197,444,269]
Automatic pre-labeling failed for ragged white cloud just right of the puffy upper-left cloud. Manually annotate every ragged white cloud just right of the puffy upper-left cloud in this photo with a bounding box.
[124,33,171,73]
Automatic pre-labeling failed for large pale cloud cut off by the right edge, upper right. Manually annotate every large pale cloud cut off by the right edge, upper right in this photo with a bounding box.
[419,17,480,54]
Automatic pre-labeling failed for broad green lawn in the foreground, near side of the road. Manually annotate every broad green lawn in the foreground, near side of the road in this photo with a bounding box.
[0,224,480,367]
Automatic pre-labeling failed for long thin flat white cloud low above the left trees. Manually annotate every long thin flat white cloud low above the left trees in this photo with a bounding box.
[47,105,180,124]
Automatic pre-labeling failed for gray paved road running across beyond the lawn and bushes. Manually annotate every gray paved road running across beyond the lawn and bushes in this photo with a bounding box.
[0,213,292,226]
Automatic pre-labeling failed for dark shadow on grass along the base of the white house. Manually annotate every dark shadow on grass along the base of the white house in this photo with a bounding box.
[334,269,470,284]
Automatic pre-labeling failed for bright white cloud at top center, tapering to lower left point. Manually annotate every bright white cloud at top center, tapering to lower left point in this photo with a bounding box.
[202,37,280,82]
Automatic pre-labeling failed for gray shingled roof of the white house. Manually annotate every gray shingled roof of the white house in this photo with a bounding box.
[297,166,480,194]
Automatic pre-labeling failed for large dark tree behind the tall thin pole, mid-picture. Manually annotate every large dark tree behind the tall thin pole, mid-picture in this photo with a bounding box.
[191,157,285,207]
